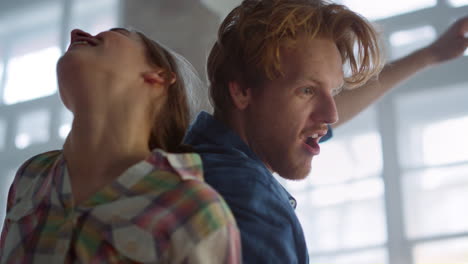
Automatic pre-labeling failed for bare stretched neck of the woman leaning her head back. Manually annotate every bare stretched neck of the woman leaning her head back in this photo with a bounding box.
[64,107,150,203]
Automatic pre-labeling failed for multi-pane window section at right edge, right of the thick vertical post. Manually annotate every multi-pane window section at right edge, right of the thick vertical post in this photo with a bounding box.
[397,83,468,263]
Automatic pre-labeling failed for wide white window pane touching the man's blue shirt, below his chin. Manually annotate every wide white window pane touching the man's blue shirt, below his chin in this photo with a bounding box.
[296,194,386,253]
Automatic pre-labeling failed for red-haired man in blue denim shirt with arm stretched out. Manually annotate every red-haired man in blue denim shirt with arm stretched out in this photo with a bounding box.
[185,0,468,263]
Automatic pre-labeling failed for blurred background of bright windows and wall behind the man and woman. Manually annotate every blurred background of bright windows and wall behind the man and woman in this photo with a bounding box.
[0,0,468,264]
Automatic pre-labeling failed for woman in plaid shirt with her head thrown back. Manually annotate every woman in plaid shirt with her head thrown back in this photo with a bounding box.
[0,28,240,263]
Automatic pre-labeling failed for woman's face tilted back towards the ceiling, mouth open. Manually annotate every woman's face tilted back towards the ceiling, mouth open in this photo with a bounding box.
[57,28,154,111]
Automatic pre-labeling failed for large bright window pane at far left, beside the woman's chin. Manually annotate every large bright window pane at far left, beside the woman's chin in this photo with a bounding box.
[4,32,61,104]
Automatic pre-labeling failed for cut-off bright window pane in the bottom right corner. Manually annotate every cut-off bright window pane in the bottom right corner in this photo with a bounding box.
[413,238,468,264]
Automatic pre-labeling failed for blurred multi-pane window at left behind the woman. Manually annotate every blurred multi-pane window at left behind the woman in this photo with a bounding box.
[0,0,119,227]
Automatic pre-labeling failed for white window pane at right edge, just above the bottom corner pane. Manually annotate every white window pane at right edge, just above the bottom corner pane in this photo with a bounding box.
[403,165,468,238]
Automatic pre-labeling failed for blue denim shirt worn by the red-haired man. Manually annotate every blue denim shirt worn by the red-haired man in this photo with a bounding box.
[184,112,331,264]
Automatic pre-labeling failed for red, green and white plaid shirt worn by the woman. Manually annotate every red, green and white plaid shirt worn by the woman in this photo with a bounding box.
[0,150,241,264]
